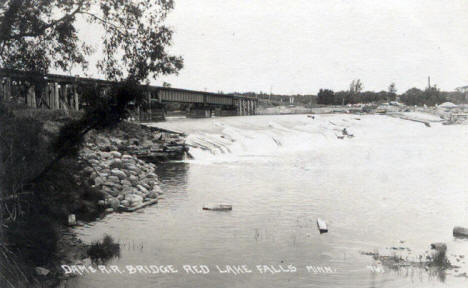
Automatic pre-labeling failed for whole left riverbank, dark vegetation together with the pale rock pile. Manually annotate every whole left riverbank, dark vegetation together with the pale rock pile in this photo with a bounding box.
[0,105,187,287]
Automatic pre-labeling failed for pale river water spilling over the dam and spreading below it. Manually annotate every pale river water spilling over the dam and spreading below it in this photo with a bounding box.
[66,114,468,288]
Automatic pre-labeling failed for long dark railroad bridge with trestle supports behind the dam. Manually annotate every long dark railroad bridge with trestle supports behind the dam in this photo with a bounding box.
[0,69,257,121]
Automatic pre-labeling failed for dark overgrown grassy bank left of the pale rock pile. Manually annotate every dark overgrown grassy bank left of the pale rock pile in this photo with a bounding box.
[0,103,104,287]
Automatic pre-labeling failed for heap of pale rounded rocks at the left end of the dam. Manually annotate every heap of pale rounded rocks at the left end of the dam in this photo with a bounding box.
[75,123,187,216]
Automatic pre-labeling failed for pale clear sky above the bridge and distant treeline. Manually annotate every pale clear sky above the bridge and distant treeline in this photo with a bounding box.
[75,0,468,94]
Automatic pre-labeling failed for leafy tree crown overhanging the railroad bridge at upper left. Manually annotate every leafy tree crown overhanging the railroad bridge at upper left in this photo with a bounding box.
[0,0,183,81]
